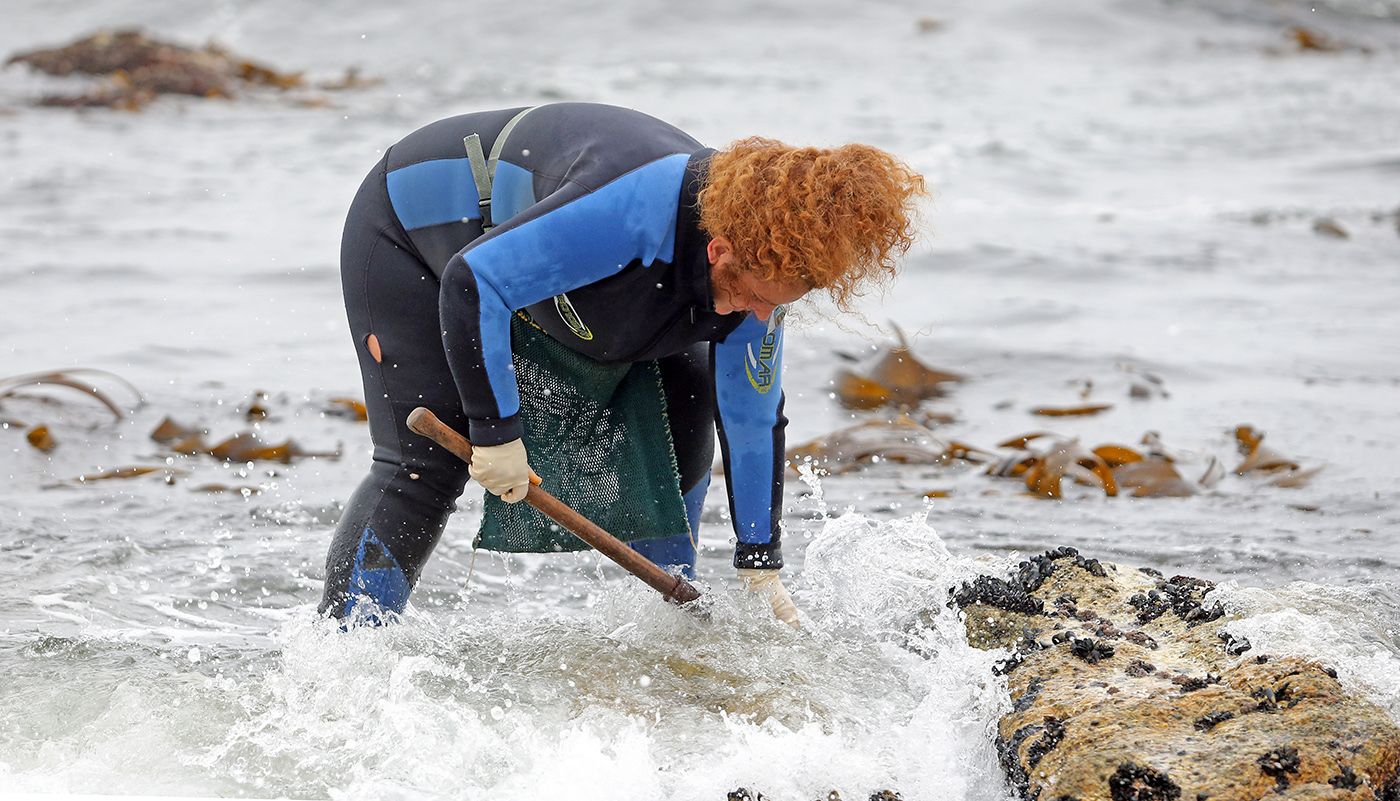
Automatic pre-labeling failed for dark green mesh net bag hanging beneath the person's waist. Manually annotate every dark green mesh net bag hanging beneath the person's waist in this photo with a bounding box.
[476,315,689,553]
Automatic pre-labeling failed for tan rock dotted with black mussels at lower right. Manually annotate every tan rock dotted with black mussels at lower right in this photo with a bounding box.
[949,548,1400,801]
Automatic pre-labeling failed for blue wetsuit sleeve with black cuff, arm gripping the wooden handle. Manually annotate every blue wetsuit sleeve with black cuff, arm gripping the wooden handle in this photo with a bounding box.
[438,155,687,445]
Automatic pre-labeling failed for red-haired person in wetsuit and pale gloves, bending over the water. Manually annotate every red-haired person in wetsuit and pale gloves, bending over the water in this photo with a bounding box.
[321,102,924,625]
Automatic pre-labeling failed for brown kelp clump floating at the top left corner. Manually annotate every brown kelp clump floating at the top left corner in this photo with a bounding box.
[7,29,377,111]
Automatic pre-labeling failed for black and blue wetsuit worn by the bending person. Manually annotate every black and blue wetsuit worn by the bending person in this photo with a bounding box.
[321,102,787,616]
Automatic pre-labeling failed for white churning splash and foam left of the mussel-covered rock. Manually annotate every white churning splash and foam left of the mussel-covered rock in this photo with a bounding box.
[0,515,1007,801]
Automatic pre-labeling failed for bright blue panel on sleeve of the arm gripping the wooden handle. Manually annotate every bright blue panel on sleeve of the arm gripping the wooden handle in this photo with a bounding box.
[462,154,690,417]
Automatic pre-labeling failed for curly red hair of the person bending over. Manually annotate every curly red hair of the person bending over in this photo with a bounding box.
[700,137,927,308]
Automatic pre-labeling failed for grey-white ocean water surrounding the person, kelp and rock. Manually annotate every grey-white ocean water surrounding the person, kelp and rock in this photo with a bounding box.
[0,0,1400,801]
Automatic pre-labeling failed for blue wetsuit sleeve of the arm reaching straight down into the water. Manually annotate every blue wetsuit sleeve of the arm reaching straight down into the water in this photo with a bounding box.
[710,308,787,569]
